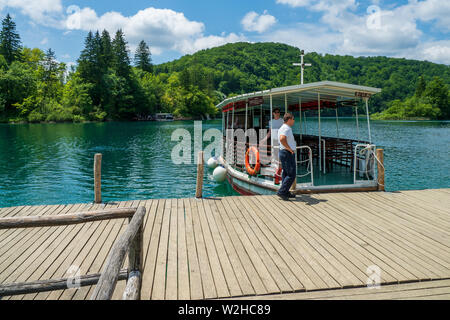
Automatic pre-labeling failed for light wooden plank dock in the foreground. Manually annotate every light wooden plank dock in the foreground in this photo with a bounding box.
[0,189,450,300]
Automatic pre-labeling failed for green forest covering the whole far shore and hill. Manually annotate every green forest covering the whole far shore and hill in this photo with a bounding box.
[0,14,450,123]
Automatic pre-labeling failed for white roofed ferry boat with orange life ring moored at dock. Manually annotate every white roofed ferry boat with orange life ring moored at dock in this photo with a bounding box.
[217,81,384,195]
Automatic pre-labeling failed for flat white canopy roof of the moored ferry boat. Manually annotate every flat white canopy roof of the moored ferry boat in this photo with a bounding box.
[217,81,381,112]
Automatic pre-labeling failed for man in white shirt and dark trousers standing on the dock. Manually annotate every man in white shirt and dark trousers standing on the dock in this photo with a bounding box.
[278,113,297,201]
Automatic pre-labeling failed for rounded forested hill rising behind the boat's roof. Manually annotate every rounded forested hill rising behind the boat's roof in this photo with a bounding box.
[155,43,450,112]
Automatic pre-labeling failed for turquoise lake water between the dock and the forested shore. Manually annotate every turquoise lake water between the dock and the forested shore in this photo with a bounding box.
[0,119,450,207]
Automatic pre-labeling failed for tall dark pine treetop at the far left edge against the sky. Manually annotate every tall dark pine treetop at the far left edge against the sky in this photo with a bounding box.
[0,13,22,64]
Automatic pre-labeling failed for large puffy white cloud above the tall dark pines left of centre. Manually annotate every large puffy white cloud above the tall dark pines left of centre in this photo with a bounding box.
[65,8,245,54]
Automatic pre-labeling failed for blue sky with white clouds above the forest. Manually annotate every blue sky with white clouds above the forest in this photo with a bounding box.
[0,0,450,65]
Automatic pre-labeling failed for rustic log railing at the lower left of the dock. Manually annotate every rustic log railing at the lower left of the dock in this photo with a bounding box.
[0,207,146,300]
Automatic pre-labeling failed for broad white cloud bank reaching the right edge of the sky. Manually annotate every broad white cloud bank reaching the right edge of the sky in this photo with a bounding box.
[274,0,450,64]
